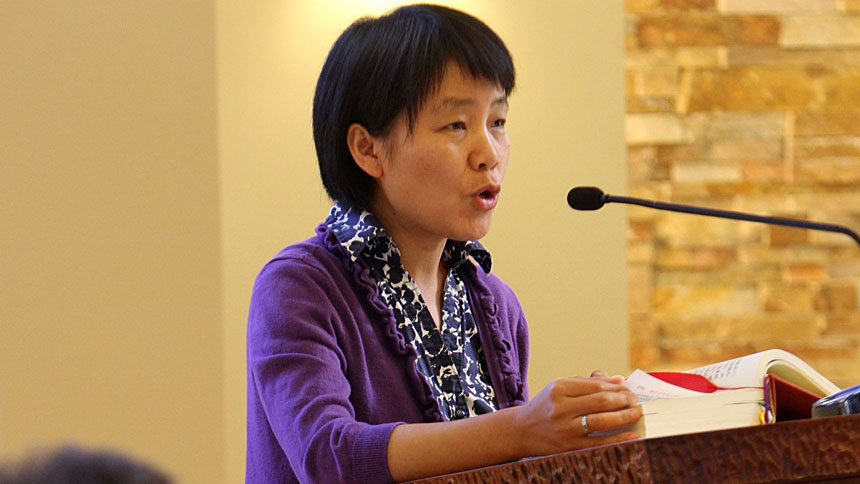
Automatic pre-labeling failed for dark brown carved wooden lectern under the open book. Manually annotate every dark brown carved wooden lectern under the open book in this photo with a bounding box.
[408,415,860,484]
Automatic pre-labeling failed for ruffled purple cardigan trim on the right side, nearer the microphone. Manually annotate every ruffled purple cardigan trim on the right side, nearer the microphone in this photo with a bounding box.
[461,264,525,403]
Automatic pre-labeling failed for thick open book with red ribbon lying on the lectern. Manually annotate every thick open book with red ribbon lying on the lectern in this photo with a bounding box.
[607,349,839,438]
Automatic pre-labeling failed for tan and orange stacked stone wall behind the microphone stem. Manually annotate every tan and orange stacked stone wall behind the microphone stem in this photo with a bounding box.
[625,0,860,386]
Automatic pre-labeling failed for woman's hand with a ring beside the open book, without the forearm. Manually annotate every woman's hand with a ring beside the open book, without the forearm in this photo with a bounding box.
[516,371,642,455]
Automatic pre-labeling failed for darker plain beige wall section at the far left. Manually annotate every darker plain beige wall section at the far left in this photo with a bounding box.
[0,0,224,484]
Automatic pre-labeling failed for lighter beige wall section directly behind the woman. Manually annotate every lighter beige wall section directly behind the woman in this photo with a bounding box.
[216,0,627,482]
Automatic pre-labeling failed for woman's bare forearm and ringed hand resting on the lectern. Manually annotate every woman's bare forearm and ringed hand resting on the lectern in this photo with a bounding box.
[388,372,642,481]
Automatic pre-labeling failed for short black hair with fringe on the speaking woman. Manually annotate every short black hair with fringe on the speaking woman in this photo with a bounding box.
[313,5,514,209]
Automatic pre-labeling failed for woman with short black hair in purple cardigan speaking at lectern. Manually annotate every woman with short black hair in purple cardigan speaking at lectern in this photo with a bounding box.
[246,5,640,483]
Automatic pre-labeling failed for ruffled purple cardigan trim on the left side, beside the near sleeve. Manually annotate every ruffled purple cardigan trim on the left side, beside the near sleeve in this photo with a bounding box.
[316,224,444,422]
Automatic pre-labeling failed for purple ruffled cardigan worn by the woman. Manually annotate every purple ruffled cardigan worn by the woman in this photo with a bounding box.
[245,225,528,484]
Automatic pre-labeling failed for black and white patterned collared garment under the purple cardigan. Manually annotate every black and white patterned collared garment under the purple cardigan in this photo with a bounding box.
[325,202,498,420]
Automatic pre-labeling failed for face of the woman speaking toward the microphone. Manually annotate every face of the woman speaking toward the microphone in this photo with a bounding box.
[372,63,510,248]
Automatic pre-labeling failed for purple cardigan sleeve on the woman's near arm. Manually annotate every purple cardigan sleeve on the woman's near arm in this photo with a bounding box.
[247,251,399,484]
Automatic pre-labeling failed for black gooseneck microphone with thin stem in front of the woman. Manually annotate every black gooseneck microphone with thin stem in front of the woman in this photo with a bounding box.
[567,187,860,245]
